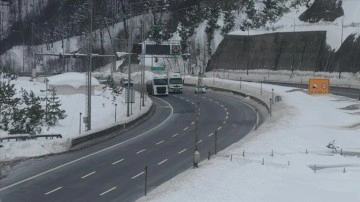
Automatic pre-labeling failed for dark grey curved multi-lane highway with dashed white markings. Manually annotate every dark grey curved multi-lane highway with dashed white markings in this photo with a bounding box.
[0,90,257,202]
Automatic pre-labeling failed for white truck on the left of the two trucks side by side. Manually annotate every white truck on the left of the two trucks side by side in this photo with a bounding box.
[146,74,169,95]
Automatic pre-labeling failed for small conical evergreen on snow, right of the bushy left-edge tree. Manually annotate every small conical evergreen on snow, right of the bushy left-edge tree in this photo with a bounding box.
[46,88,67,126]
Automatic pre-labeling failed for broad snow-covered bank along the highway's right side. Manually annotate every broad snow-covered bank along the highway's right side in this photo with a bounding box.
[139,77,360,202]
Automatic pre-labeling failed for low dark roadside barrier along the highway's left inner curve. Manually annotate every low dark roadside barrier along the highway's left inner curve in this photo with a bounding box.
[71,104,155,148]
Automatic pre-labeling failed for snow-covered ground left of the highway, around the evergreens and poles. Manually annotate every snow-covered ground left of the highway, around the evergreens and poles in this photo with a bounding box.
[0,74,152,162]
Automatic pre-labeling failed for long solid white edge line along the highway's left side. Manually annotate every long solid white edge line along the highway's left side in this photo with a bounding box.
[0,97,174,192]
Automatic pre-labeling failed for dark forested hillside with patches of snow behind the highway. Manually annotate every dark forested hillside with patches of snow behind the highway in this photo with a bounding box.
[0,0,352,73]
